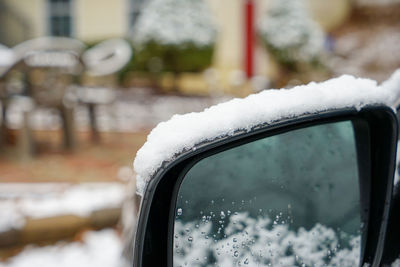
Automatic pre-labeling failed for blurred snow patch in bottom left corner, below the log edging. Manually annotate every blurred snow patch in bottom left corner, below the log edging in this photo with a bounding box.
[0,229,125,267]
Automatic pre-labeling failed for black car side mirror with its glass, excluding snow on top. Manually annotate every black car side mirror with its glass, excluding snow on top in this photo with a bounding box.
[134,105,397,266]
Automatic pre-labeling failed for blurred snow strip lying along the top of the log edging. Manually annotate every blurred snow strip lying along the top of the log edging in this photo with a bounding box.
[0,183,126,232]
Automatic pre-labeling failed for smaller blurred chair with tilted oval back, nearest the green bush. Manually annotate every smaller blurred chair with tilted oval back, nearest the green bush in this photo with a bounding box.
[76,38,132,142]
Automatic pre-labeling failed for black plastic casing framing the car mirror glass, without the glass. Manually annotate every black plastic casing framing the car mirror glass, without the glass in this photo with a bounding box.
[134,106,398,267]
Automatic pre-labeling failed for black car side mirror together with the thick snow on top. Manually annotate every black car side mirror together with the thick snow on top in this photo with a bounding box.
[133,71,400,267]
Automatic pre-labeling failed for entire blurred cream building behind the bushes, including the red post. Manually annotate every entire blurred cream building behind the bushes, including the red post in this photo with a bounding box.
[0,0,351,93]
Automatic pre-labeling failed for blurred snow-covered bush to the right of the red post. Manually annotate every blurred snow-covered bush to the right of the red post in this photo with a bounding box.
[258,0,324,68]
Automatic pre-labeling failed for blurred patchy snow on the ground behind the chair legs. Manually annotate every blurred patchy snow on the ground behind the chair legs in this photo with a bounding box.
[0,88,227,132]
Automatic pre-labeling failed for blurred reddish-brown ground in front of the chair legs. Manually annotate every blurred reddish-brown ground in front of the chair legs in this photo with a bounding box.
[0,131,147,183]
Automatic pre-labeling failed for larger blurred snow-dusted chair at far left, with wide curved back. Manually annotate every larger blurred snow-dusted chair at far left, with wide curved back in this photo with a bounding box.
[0,37,85,158]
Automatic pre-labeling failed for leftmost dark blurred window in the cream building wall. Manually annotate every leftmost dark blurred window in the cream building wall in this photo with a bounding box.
[48,0,72,36]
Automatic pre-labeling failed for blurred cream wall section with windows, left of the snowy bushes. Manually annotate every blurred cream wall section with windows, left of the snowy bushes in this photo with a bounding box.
[0,0,142,46]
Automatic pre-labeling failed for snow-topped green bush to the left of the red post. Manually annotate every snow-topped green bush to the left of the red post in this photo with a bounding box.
[132,0,216,73]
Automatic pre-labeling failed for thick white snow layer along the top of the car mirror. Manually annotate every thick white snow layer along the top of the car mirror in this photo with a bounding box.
[133,71,400,195]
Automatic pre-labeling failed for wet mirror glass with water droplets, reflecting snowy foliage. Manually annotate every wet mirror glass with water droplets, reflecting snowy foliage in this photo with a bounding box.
[173,121,362,267]
